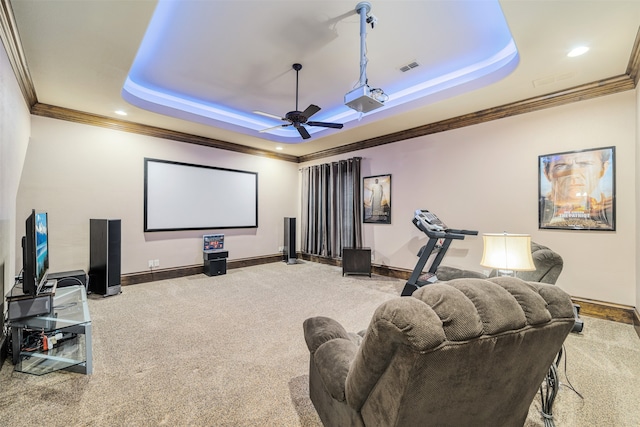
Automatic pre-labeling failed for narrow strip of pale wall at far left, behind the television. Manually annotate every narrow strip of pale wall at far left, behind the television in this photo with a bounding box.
[0,42,31,298]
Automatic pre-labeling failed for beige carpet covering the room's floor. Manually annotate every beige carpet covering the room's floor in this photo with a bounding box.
[0,262,640,427]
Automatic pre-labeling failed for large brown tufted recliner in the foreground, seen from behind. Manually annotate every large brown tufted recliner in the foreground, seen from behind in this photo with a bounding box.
[304,277,574,427]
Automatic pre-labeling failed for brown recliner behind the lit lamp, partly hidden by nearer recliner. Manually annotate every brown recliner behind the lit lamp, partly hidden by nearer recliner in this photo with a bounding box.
[436,242,564,285]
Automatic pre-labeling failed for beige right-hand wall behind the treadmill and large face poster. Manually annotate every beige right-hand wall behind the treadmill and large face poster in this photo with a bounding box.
[301,91,637,306]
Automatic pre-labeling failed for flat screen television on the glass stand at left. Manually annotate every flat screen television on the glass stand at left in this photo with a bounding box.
[22,210,49,296]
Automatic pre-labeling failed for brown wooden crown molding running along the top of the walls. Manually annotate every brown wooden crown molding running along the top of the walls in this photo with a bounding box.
[5,4,640,163]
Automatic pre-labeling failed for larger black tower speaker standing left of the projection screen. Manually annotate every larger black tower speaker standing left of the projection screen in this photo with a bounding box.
[89,219,122,296]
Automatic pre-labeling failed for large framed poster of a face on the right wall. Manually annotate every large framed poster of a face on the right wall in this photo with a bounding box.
[538,147,616,231]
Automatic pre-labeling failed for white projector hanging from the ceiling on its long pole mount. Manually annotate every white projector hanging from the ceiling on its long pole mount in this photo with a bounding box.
[344,1,389,113]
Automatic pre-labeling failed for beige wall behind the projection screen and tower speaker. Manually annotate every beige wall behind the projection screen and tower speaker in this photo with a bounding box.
[16,116,298,274]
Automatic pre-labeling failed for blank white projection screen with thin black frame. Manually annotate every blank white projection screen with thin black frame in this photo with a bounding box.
[144,159,258,232]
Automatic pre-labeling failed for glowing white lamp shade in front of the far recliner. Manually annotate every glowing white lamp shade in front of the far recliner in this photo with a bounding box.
[480,233,535,271]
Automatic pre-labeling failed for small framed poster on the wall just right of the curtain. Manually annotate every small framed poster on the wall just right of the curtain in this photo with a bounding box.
[362,174,391,224]
